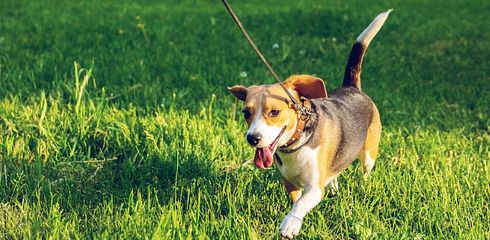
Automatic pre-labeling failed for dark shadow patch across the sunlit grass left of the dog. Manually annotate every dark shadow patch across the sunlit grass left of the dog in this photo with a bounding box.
[0,149,218,211]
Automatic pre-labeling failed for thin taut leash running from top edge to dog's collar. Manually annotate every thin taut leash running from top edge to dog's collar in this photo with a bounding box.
[221,0,311,116]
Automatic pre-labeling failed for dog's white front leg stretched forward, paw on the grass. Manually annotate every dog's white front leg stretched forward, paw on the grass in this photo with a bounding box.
[279,186,324,238]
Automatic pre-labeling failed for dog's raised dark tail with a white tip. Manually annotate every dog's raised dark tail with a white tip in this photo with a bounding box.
[342,9,393,89]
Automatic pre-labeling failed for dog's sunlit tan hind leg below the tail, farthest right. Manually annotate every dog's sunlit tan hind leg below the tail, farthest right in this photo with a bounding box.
[359,104,381,178]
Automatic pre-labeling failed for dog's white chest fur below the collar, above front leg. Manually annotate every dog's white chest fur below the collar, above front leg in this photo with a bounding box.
[276,146,320,187]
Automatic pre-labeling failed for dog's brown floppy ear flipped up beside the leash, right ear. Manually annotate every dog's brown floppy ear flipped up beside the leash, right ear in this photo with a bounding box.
[284,75,327,99]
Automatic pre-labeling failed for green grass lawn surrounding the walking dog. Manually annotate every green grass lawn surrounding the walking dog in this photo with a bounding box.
[0,0,490,239]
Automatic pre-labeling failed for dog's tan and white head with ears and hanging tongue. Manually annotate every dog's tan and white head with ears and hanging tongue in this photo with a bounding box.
[228,75,327,168]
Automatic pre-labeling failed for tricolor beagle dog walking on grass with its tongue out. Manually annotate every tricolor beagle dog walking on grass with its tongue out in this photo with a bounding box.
[228,10,391,238]
